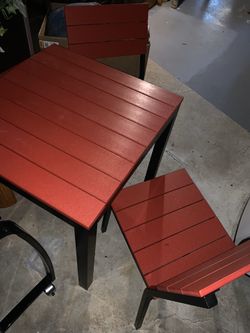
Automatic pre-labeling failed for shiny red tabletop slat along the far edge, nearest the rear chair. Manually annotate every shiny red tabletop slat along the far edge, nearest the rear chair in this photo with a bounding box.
[43,45,183,109]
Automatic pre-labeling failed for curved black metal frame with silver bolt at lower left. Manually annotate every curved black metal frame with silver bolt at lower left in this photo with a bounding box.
[0,220,55,333]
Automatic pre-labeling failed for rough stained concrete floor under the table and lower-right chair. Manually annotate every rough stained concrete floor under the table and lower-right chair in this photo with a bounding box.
[0,60,250,333]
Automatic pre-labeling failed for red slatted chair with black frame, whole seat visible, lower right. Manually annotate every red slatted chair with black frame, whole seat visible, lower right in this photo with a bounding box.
[112,169,250,328]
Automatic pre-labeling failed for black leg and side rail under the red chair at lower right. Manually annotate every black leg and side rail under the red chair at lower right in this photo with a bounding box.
[134,288,218,329]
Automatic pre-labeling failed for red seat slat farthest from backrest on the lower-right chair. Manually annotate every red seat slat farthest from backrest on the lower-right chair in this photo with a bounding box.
[112,169,193,212]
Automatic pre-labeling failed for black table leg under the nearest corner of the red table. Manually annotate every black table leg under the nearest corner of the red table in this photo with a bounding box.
[75,223,97,289]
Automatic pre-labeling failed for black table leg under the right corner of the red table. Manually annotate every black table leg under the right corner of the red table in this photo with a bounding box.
[144,117,176,181]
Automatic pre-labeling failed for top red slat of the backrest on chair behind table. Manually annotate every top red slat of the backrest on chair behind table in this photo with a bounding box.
[64,3,148,25]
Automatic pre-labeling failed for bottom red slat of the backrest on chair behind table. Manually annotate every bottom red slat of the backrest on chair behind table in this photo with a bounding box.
[69,39,147,59]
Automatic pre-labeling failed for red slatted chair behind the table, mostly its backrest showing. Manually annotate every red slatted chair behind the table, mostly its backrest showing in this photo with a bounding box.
[64,3,148,79]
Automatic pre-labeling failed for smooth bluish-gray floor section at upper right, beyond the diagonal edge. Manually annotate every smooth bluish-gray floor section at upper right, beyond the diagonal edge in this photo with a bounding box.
[149,0,250,131]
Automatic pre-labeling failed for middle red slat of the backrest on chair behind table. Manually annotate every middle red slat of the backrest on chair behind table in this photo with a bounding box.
[67,21,148,45]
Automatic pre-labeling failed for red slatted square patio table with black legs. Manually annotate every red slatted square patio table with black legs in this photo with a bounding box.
[0,45,182,289]
